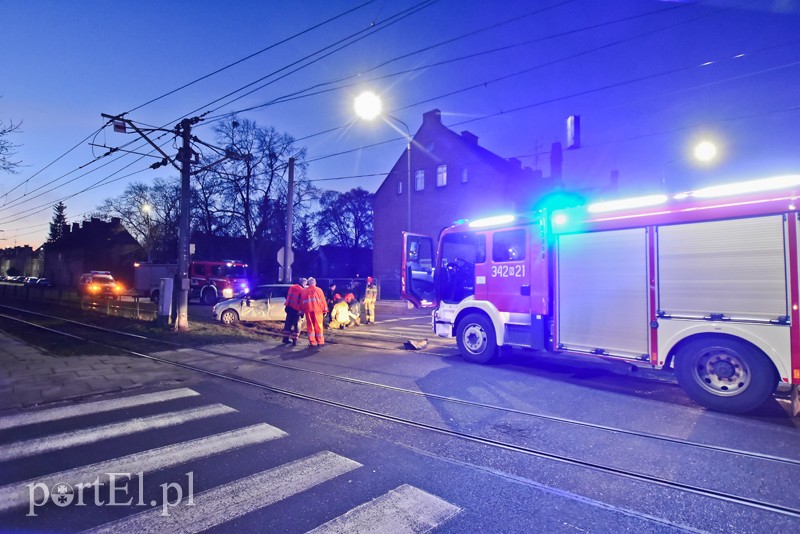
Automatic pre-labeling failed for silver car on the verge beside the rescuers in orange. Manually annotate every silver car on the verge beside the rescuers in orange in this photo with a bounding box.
[211,284,291,324]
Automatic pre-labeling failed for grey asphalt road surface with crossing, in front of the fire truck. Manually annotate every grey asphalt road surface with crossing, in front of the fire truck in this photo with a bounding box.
[0,306,800,532]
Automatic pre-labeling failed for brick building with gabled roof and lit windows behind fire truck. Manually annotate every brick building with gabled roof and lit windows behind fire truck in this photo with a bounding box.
[373,109,549,299]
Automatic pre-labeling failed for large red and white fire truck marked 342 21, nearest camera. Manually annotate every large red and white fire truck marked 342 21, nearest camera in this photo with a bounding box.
[402,175,800,413]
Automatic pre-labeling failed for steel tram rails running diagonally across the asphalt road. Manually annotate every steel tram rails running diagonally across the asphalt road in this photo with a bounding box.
[0,305,800,519]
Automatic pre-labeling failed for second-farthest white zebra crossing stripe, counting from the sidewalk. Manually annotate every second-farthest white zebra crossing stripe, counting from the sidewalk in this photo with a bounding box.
[0,404,236,462]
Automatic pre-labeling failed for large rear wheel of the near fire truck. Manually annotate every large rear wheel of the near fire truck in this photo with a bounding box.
[675,336,778,413]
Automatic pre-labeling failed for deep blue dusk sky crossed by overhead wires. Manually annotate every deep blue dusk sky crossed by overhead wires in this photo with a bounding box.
[0,0,800,248]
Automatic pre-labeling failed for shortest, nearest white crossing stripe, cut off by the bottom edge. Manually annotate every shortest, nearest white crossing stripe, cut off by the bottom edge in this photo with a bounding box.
[309,484,461,534]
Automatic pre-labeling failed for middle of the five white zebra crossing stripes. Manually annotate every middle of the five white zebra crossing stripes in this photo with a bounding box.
[0,423,288,512]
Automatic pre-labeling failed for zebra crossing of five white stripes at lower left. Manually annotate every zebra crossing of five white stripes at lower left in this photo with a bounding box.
[0,388,461,533]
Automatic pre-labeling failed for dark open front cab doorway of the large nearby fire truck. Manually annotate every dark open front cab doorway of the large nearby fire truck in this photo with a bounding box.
[439,233,486,303]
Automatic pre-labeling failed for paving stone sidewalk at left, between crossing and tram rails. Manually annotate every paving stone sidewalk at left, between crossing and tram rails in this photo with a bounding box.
[0,332,200,413]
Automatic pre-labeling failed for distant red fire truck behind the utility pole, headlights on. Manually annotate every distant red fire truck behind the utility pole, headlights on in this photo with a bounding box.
[134,260,249,305]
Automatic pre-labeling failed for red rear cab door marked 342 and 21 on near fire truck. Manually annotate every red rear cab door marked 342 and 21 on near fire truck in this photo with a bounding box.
[484,227,531,316]
